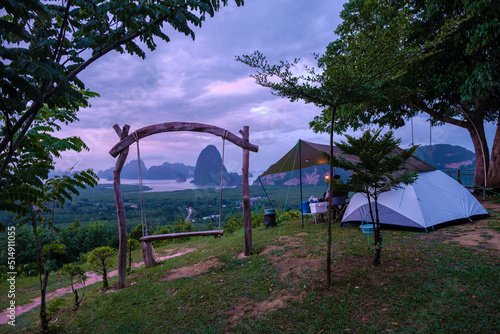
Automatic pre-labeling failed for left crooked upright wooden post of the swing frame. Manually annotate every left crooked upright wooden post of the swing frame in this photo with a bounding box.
[113,124,130,289]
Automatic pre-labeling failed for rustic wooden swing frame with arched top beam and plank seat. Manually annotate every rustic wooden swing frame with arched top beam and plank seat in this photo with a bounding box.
[109,122,259,288]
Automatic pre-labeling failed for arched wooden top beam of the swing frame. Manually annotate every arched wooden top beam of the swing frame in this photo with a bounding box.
[109,122,259,158]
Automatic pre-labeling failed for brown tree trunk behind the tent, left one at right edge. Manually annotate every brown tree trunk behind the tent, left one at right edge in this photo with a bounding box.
[467,122,489,187]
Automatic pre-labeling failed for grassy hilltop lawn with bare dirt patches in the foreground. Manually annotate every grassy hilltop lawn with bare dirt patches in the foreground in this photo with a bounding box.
[0,205,500,333]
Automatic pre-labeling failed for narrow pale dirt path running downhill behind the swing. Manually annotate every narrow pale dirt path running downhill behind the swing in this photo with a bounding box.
[0,248,196,324]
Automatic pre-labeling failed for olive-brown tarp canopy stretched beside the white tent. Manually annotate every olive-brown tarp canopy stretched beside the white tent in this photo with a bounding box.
[261,139,436,176]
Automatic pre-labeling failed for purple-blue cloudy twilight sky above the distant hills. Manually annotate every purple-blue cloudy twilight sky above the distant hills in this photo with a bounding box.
[56,0,494,172]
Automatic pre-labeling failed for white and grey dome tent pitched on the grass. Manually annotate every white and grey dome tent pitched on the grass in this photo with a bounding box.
[342,170,489,231]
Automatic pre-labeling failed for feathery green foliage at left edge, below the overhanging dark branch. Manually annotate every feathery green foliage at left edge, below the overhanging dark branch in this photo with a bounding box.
[0,97,97,222]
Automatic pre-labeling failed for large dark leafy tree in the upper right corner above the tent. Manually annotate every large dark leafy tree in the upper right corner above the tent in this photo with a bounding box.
[313,0,500,187]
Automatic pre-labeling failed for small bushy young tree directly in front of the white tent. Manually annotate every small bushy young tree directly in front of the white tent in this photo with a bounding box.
[328,130,418,266]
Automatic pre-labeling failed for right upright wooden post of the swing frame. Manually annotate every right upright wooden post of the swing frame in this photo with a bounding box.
[240,126,253,256]
